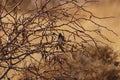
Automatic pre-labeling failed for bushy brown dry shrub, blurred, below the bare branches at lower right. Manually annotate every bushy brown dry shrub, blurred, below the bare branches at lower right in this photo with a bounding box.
[18,46,120,80]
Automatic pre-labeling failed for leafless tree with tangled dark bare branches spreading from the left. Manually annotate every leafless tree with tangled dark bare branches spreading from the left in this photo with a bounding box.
[0,0,117,80]
